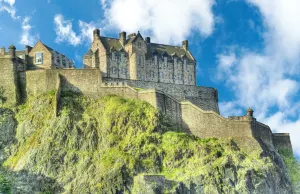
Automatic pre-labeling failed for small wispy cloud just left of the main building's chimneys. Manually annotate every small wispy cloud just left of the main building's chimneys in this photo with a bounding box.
[54,14,96,46]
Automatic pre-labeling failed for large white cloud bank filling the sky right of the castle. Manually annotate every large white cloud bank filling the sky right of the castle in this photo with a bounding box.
[217,0,300,158]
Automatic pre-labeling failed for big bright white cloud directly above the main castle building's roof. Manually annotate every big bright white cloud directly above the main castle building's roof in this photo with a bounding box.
[101,0,215,44]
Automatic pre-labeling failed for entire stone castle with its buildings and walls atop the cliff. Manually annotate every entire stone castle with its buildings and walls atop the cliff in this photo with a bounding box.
[0,29,292,155]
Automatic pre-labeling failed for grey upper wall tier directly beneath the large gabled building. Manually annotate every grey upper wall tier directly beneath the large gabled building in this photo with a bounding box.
[103,78,219,113]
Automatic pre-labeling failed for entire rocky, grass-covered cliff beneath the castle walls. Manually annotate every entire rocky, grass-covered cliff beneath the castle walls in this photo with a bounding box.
[0,92,300,194]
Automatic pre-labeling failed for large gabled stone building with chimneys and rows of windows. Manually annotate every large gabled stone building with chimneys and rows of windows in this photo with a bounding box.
[83,29,196,85]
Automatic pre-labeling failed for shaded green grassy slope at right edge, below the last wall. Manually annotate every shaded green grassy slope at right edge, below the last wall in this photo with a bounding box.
[279,149,300,192]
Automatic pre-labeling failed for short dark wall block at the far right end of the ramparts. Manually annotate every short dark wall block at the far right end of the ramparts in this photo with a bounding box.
[273,133,293,153]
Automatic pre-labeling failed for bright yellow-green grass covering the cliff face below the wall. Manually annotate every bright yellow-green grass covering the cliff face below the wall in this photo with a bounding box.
[4,92,278,193]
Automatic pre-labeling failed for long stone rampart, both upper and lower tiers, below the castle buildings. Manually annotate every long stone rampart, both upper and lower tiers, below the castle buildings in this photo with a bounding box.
[0,65,278,147]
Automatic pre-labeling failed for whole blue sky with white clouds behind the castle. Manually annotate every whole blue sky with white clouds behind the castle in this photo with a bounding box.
[0,0,300,160]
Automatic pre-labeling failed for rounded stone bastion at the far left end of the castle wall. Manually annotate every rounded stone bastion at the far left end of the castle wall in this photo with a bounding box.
[0,55,20,104]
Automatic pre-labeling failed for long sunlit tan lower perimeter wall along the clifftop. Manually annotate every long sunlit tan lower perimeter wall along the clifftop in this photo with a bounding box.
[1,65,274,145]
